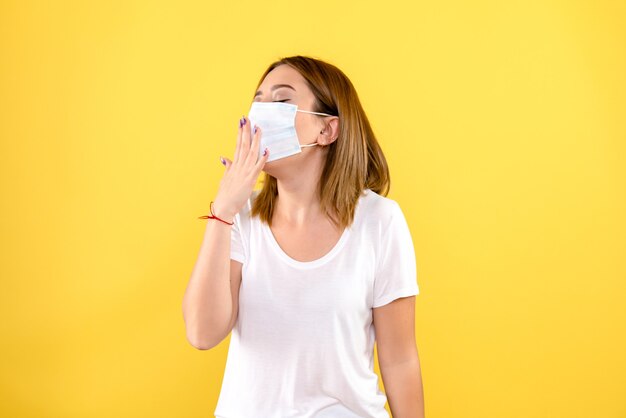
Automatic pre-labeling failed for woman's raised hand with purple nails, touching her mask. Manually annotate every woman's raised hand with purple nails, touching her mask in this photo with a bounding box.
[213,116,269,222]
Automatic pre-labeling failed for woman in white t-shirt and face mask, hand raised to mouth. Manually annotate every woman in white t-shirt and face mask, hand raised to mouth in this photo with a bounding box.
[183,56,424,418]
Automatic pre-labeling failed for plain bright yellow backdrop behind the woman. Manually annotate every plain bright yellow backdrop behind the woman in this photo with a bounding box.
[0,0,626,418]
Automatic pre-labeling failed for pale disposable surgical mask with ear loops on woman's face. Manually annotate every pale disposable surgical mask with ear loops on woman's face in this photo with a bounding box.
[248,102,332,162]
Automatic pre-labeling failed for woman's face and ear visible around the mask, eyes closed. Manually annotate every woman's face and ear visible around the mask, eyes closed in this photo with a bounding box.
[253,64,325,170]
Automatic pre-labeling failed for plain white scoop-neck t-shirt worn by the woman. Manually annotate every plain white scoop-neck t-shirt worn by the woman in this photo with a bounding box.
[215,189,419,418]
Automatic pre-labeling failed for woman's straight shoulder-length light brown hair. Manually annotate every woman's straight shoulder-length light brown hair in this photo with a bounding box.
[251,55,390,230]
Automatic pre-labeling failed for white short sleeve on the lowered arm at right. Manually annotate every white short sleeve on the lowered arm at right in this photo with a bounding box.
[372,201,419,308]
